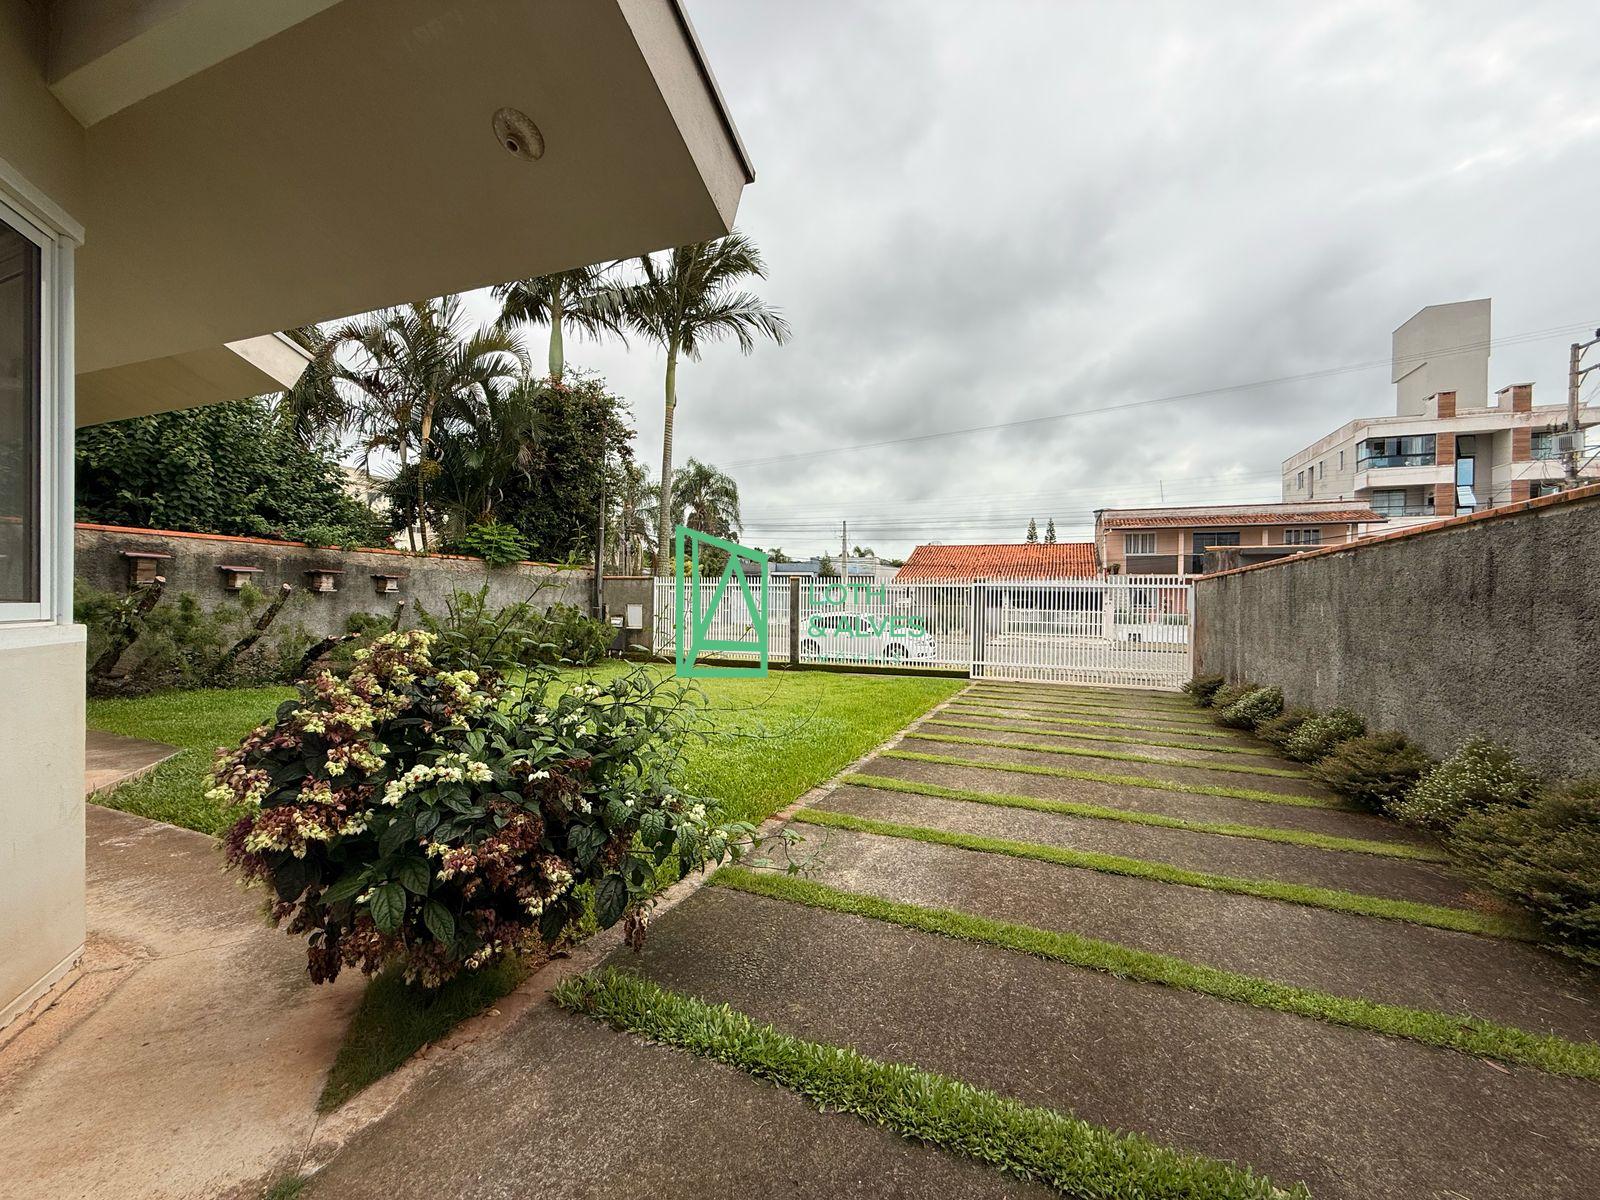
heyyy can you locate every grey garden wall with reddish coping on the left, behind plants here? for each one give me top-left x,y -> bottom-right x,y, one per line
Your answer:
77,525 -> 651,642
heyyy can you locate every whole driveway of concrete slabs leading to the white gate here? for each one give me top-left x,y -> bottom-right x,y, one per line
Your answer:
302,683 -> 1600,1200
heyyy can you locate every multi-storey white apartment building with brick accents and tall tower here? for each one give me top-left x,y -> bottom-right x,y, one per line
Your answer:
1283,299 -> 1600,526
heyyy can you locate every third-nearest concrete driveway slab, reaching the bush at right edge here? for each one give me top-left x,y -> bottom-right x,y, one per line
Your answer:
784,827 -> 1600,1040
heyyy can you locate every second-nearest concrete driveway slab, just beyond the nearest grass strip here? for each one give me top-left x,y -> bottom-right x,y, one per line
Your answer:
616,888 -> 1600,1200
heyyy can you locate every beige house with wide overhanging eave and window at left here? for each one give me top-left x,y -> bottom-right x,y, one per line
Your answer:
0,0 -> 752,1026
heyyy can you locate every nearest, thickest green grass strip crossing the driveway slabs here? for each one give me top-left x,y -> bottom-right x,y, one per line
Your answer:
554,970 -> 1309,1200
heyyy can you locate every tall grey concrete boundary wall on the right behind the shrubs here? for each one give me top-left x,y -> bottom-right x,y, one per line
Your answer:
1195,486 -> 1600,776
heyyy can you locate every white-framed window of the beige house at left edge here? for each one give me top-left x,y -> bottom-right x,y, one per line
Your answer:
0,203 -> 51,621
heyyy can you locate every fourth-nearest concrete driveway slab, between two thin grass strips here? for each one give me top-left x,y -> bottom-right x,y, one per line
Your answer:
816,786 -> 1477,907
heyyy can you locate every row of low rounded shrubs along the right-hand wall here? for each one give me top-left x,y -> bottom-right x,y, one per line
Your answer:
1186,675 -> 1600,965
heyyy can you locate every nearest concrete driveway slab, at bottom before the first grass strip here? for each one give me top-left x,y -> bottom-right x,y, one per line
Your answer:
307,998 -> 1046,1200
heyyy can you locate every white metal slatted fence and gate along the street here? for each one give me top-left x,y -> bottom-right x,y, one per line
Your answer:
653,574 -> 1192,688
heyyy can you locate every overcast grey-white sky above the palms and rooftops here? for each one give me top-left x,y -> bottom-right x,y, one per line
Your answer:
467,0 -> 1600,557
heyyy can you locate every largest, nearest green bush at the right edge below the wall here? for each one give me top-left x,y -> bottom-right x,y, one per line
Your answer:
1450,779 -> 1600,966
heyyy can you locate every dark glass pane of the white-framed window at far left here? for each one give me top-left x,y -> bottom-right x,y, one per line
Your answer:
0,219 -> 42,603
